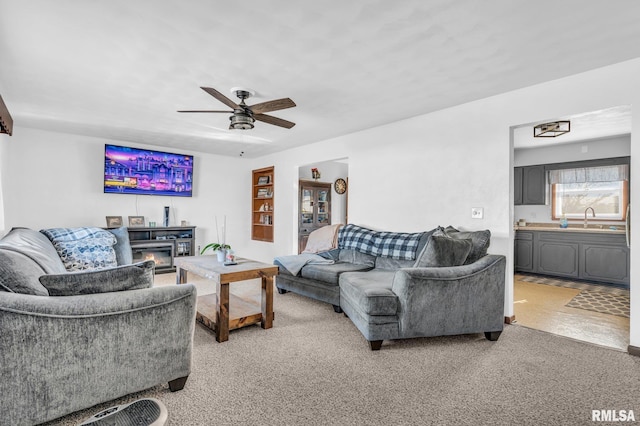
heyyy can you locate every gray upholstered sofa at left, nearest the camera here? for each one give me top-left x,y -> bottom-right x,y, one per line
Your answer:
0,228 -> 196,425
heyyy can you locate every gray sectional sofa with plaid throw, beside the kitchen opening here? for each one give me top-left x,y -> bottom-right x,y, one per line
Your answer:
274,225 -> 506,350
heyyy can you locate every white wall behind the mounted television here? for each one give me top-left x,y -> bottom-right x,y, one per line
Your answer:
0,128 -> 251,256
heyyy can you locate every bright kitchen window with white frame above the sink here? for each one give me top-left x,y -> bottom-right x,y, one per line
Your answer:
549,164 -> 629,221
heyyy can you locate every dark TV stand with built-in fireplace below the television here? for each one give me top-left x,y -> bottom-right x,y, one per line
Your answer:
127,226 -> 196,273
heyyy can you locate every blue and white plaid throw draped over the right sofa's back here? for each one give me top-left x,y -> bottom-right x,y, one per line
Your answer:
338,225 -> 424,260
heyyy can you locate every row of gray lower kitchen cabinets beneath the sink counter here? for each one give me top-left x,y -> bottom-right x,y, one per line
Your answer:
514,230 -> 630,287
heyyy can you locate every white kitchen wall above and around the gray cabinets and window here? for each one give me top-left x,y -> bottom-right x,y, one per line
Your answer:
513,135 -> 631,225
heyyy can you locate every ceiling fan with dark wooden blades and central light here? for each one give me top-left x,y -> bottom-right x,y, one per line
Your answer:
178,87 -> 296,130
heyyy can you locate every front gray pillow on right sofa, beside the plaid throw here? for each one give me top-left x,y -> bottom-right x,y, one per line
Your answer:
413,235 -> 472,268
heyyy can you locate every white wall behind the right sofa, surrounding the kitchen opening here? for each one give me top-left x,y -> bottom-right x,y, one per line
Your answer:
247,56 -> 640,346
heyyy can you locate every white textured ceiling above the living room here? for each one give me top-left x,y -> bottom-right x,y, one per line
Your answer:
0,0 -> 640,157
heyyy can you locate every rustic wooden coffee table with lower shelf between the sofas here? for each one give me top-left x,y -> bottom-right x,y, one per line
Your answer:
174,256 -> 278,342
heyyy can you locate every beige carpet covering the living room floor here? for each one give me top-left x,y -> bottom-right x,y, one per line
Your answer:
41,278 -> 640,426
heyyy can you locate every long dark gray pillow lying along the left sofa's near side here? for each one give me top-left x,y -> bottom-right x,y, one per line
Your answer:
40,260 -> 155,296
